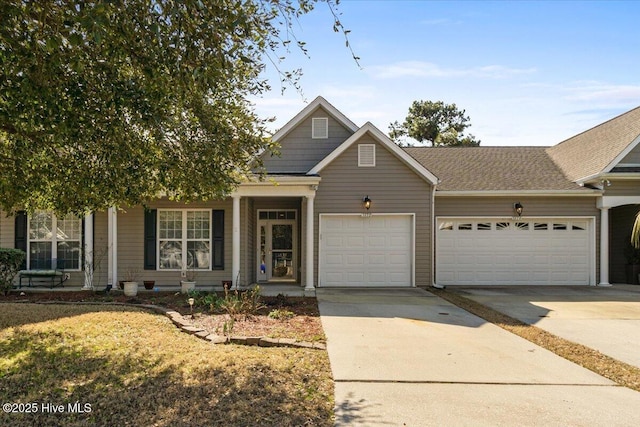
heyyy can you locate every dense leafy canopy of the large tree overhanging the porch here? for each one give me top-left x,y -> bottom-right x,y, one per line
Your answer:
0,0 -> 350,213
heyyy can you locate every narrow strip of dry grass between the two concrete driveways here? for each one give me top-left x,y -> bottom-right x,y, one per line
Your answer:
430,289 -> 640,391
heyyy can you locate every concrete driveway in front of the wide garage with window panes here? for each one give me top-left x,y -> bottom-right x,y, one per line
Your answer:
449,285 -> 640,368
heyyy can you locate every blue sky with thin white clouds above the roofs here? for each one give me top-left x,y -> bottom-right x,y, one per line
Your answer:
253,0 -> 640,146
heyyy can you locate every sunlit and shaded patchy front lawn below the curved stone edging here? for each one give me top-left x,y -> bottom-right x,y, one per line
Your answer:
0,303 -> 333,426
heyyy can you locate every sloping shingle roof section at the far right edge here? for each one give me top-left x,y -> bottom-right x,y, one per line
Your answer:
547,107 -> 640,182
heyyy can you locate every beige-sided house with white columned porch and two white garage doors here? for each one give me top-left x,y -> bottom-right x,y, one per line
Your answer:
0,97 -> 640,290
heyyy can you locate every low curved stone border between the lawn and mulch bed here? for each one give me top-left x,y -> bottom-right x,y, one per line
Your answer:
2,300 -> 327,350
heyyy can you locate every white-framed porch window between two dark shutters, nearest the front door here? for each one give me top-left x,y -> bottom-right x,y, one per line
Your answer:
158,210 -> 211,270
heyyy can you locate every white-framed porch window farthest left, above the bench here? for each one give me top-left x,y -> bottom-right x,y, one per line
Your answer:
28,211 -> 82,270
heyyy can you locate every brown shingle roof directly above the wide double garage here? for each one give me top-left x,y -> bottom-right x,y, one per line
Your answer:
404,147 -> 586,192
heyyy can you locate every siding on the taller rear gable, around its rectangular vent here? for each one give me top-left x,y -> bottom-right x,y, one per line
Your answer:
262,107 -> 352,173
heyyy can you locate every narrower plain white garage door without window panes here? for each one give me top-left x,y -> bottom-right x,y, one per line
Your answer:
318,214 -> 414,287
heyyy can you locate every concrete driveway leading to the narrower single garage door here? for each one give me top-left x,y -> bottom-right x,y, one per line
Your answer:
317,289 -> 640,426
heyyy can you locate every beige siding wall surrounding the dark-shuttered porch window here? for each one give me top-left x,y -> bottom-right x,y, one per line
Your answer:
117,199 -> 232,289
